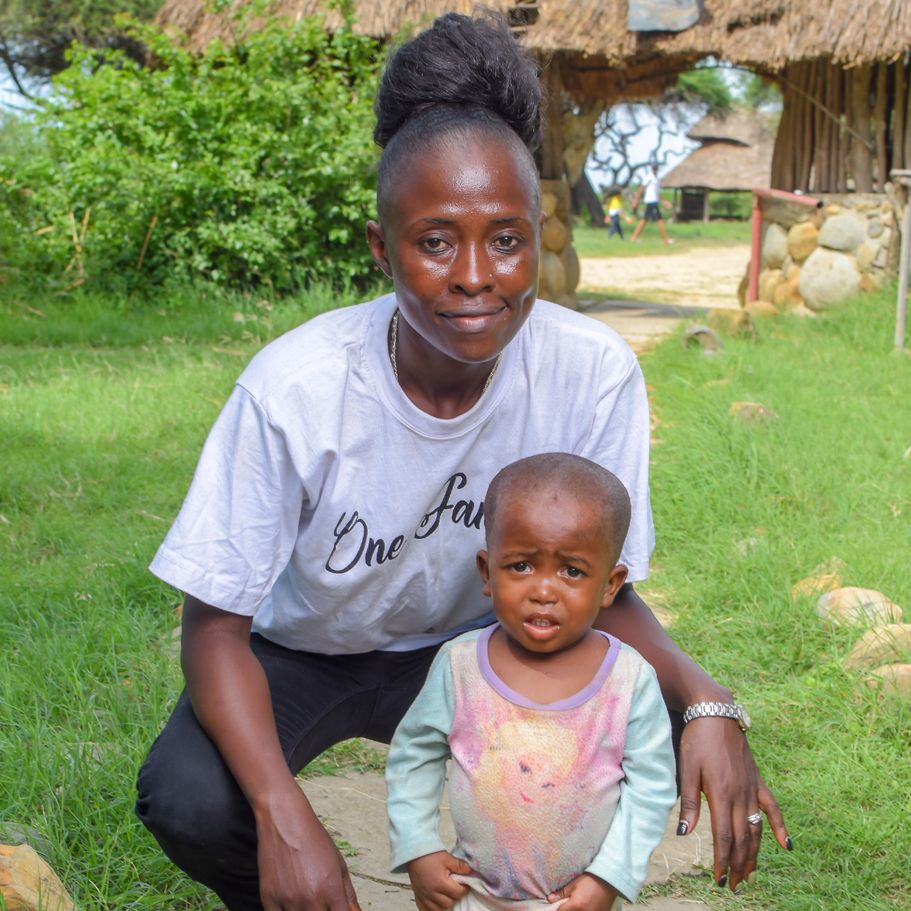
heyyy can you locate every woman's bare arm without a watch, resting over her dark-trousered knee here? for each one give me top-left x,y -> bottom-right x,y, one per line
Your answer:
181,595 -> 359,911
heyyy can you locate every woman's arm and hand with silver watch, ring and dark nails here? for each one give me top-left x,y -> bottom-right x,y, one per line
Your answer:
595,584 -> 791,889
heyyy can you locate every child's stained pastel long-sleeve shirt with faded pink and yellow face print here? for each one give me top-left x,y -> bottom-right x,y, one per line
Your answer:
386,627 -> 676,901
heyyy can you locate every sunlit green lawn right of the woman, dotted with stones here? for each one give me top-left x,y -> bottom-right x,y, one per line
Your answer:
644,290 -> 911,911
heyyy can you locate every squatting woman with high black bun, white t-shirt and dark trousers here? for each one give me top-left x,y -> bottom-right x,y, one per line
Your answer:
137,15 -> 787,911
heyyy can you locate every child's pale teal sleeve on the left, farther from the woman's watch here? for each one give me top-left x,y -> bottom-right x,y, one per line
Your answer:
386,646 -> 455,873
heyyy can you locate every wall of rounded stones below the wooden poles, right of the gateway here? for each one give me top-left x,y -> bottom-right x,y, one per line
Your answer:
752,193 -> 899,312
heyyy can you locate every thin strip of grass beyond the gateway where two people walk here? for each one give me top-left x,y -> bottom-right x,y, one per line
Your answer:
573,221 -> 750,257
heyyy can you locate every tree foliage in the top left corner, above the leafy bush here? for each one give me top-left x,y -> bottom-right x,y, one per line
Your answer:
0,0 -> 162,97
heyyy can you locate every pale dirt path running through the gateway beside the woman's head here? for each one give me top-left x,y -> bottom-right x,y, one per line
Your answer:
577,244 -> 750,354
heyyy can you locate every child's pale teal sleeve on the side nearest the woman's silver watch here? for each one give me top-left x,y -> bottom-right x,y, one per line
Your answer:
586,661 -> 677,902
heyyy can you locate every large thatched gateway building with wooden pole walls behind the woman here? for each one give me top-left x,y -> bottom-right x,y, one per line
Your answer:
158,0 -> 911,303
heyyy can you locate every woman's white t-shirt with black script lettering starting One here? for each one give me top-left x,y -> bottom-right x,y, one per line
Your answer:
151,294 -> 654,654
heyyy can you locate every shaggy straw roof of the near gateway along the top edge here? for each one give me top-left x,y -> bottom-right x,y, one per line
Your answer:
158,0 -> 911,76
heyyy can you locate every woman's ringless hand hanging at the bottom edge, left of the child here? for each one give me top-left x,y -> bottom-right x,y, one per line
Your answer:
256,785 -> 360,911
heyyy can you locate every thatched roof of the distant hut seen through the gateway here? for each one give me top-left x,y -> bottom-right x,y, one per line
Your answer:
661,111 -> 775,190
